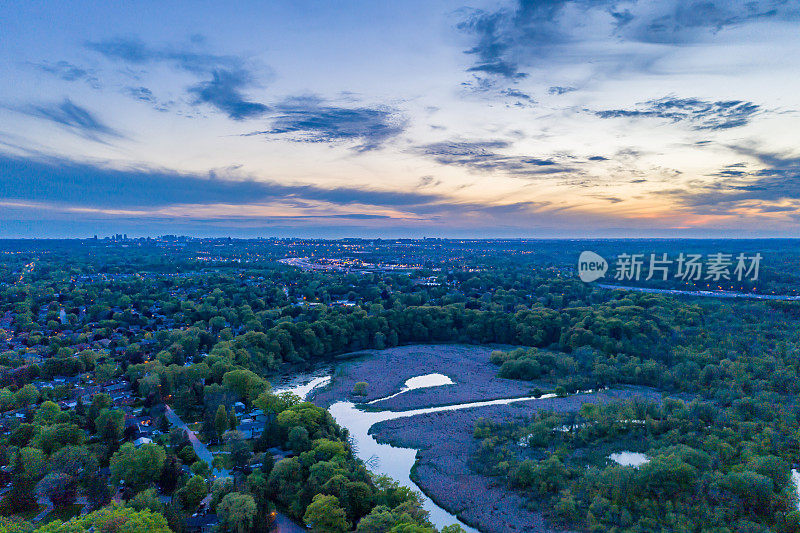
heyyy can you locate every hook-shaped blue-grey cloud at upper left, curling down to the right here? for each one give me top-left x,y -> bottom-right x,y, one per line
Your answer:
86,38 -> 268,120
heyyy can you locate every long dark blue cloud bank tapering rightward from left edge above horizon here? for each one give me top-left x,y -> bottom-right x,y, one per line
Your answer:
0,153 -> 443,209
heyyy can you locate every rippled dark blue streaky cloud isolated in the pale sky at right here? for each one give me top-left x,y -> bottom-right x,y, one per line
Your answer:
595,97 -> 761,130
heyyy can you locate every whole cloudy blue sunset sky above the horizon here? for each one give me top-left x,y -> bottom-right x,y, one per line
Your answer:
0,0 -> 800,238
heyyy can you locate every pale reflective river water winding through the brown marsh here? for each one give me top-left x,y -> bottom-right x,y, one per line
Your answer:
274,372 -> 568,533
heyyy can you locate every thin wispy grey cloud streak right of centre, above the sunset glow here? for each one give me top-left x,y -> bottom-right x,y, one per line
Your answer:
415,141 -> 575,178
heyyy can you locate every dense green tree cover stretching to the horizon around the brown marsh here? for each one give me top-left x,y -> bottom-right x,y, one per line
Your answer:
0,241 -> 800,533
